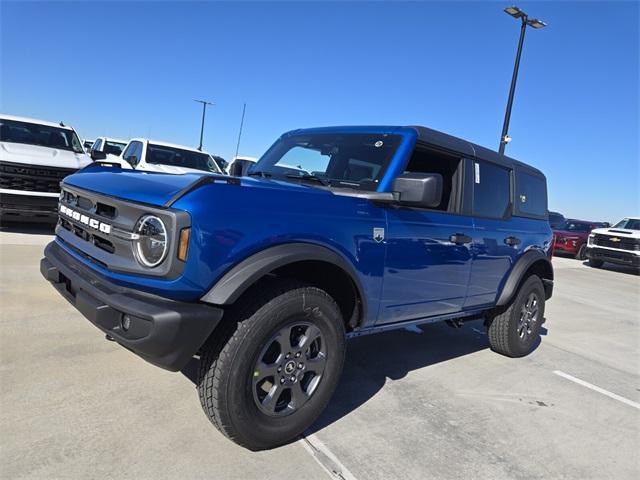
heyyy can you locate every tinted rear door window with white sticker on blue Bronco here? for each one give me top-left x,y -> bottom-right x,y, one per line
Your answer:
473,162 -> 511,218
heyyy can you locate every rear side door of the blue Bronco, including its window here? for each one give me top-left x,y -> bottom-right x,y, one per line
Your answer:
464,159 -> 525,307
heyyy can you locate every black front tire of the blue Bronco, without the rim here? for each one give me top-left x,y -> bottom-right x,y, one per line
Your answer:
198,280 -> 346,451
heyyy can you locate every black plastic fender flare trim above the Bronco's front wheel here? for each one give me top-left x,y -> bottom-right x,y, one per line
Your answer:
200,243 -> 367,318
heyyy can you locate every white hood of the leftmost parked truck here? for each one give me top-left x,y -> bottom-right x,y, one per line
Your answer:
0,142 -> 91,168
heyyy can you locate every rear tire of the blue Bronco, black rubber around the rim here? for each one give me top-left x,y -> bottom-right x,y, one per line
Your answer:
487,275 -> 545,358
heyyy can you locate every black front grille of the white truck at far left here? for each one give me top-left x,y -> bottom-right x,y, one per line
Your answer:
0,162 -> 76,193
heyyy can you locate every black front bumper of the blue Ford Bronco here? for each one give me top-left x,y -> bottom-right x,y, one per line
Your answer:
40,242 -> 223,371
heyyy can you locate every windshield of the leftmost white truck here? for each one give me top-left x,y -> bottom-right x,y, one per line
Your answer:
0,119 -> 84,153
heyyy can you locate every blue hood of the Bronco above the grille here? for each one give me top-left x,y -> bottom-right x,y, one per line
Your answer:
63,165 -> 330,206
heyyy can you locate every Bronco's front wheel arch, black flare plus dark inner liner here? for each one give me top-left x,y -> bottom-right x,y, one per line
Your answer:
200,243 -> 367,328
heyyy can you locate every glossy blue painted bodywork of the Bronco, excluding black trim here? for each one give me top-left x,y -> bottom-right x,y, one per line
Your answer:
59,127 -> 551,328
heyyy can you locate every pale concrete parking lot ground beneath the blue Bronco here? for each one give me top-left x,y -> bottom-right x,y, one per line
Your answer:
0,228 -> 640,479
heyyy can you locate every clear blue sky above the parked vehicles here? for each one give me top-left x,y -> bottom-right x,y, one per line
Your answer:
0,0 -> 640,221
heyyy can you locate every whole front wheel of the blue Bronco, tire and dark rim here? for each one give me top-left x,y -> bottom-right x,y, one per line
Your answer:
198,281 -> 345,450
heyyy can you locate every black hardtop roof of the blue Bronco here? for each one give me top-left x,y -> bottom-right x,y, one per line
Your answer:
407,125 -> 544,177
